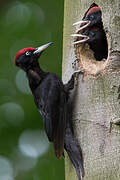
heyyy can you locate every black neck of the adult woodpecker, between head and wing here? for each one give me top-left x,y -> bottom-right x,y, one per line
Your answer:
26,62 -> 47,92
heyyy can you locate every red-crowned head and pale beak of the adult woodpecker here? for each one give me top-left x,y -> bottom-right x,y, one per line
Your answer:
15,42 -> 52,71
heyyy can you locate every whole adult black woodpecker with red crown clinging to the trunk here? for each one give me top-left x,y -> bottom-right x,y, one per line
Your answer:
15,43 -> 84,180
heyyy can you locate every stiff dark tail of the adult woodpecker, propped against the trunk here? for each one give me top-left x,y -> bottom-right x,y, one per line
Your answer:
64,126 -> 84,180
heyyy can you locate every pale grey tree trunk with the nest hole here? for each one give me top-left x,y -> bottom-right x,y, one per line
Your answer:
62,0 -> 120,180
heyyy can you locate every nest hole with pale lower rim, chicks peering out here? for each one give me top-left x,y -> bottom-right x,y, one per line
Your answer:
74,4 -> 109,76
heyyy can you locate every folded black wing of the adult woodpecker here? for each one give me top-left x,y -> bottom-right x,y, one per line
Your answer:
38,75 -> 66,157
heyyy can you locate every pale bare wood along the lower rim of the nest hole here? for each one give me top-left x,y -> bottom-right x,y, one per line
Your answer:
74,44 -> 109,76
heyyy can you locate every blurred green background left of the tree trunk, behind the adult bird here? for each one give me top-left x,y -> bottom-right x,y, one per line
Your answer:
0,0 -> 64,180
